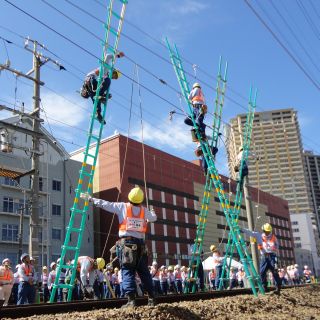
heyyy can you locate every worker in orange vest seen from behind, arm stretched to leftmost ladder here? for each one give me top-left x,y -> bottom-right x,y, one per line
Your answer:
80,187 -> 157,307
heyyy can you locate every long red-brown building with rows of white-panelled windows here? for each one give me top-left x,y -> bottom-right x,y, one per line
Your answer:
83,135 -> 293,265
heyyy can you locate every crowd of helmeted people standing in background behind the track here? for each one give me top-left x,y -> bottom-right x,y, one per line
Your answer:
0,254 -> 313,305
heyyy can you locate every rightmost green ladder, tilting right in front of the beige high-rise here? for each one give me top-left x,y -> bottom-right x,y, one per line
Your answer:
218,88 -> 257,290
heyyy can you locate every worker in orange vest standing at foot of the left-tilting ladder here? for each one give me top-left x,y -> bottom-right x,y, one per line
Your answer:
241,223 -> 281,294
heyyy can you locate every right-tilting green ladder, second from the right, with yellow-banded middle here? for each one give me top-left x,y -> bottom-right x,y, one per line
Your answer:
184,57 -> 228,293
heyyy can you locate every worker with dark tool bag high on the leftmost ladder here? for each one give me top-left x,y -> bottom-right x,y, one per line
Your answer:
80,52 -> 124,124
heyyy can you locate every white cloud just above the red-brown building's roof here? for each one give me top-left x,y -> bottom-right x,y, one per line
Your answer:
131,118 -> 195,151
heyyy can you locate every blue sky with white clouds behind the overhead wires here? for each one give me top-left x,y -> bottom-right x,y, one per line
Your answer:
0,0 -> 320,173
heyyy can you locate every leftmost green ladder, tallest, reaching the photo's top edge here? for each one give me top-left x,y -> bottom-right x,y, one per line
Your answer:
50,0 -> 128,302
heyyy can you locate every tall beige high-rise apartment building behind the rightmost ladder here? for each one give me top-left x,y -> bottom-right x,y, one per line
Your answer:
227,109 -> 313,213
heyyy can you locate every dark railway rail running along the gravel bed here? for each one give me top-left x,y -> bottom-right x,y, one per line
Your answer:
0,285 -> 312,319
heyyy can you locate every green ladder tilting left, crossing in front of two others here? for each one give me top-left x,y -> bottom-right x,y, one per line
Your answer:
166,39 -> 264,296
